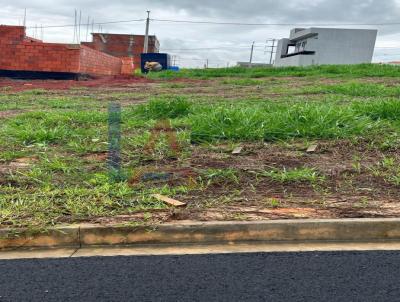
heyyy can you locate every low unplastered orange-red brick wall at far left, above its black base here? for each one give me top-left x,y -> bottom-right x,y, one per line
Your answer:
0,25 -> 133,75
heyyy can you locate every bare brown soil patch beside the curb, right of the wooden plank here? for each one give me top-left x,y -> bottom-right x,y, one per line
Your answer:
121,141 -> 400,221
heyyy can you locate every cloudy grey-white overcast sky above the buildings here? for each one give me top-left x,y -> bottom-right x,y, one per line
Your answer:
0,0 -> 400,67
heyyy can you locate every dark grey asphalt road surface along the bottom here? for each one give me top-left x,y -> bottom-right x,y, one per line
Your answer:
0,252 -> 400,302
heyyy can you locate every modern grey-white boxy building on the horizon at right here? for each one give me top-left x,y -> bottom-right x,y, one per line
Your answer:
274,27 -> 378,66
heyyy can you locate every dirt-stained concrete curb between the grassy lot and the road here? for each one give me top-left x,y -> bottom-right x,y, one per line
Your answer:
0,218 -> 400,249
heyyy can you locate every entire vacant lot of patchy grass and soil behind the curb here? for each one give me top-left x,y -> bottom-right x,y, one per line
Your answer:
0,65 -> 400,229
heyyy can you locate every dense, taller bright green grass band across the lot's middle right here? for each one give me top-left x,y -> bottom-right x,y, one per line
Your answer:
125,96 -> 400,143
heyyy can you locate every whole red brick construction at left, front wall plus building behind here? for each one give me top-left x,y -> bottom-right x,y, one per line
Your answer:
0,25 -> 159,79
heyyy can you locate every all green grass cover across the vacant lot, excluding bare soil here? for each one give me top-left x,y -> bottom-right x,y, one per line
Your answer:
0,65 -> 400,228
